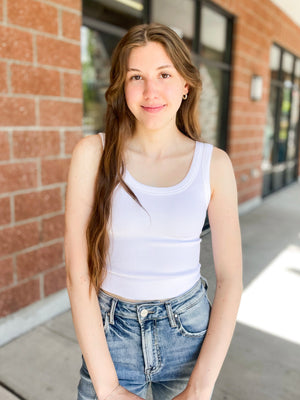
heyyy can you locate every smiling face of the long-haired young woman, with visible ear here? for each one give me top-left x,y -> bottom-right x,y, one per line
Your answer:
125,42 -> 188,134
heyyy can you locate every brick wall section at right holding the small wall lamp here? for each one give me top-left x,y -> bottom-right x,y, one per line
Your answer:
214,0 -> 300,203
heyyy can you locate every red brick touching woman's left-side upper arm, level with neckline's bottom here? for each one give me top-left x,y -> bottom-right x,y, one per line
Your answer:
15,189 -> 62,221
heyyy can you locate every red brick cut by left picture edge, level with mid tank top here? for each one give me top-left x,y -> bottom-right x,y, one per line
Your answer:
0,222 -> 39,256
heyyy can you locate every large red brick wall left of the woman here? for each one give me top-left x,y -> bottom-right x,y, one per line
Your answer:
0,0 -> 82,317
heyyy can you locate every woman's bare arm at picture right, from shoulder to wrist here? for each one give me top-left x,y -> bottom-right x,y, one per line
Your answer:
176,147 -> 243,400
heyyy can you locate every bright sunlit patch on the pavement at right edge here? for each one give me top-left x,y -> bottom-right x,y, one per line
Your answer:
237,242 -> 300,344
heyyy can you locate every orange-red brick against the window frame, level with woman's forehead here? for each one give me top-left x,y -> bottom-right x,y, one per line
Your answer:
36,36 -> 81,70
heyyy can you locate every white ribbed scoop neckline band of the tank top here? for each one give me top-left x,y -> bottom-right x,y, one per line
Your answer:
125,140 -> 200,194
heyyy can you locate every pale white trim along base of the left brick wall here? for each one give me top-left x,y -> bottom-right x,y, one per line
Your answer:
0,289 -> 70,346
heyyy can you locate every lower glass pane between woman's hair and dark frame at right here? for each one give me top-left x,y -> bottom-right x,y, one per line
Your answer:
199,64 -> 222,146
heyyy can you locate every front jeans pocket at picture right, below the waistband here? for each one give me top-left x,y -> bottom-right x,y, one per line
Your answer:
174,295 -> 211,337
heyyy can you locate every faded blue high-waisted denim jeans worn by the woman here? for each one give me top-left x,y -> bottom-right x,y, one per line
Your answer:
77,280 -> 211,400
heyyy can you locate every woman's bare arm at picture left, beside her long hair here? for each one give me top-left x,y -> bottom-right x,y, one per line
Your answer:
65,135 -> 119,400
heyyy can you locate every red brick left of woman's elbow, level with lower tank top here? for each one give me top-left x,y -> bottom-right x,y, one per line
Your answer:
17,243 -> 63,280
